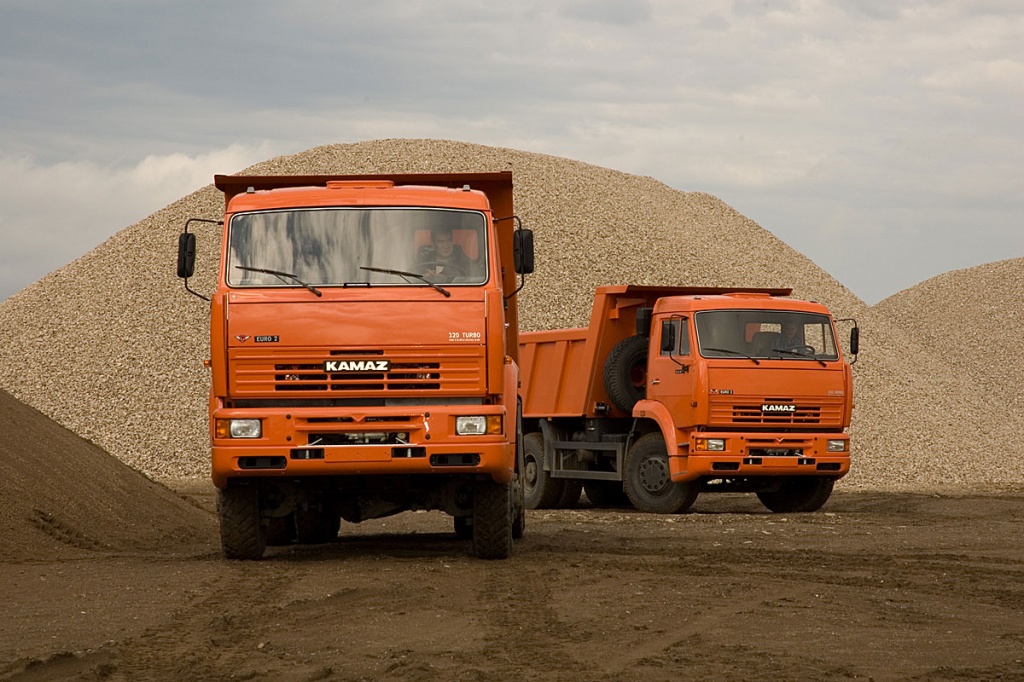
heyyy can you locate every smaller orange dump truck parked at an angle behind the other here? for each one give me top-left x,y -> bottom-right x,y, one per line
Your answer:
519,286 -> 859,513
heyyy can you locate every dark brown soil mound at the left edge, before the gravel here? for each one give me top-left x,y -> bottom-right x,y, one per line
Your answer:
0,391 -> 217,561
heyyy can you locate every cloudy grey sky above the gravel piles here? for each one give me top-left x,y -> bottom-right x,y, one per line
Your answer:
0,0 -> 1024,304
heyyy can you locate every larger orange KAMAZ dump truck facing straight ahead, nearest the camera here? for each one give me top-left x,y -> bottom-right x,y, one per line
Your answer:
178,172 -> 532,559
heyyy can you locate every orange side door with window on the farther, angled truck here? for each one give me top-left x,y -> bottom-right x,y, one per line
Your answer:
646,314 -> 693,426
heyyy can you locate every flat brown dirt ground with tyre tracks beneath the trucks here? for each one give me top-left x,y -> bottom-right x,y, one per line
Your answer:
0,481 -> 1024,682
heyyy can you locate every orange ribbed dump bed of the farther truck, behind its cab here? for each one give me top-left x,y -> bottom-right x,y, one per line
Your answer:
519,285 -> 790,418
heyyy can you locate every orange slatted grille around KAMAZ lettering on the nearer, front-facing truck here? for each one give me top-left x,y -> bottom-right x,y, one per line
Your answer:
230,346 -> 485,397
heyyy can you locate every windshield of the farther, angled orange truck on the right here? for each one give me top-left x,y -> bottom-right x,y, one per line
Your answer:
694,310 -> 839,360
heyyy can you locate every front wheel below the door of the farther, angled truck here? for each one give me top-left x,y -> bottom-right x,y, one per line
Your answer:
623,432 -> 700,514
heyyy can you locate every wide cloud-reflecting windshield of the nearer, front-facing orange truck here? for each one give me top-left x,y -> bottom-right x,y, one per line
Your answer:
226,208 -> 487,287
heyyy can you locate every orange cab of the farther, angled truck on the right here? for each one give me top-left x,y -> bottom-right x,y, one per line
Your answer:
633,293 -> 852,493
